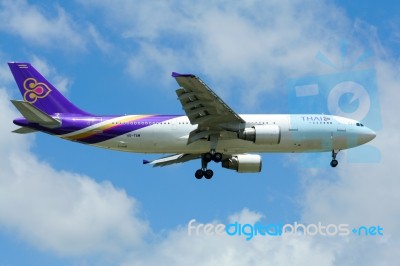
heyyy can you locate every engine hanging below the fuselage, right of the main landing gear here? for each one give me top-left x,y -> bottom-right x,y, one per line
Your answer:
222,154 -> 262,173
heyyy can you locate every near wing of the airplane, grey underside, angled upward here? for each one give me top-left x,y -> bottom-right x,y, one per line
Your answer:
172,72 -> 245,131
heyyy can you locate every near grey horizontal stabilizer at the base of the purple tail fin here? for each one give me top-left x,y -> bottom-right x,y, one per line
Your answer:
11,100 -> 61,128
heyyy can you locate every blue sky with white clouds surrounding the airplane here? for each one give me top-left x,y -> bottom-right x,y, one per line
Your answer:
0,0 -> 400,265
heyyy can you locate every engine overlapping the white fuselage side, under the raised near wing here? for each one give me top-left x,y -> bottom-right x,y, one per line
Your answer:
238,125 -> 281,144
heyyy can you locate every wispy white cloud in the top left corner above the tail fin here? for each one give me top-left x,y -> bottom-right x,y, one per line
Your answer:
0,0 -> 112,53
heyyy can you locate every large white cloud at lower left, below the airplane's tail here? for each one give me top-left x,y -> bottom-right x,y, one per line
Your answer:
0,89 -> 148,256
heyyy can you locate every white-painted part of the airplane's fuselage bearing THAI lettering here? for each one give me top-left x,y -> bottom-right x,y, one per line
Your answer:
92,114 -> 375,154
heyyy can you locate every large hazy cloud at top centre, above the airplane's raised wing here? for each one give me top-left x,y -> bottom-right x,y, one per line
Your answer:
76,1 -> 348,108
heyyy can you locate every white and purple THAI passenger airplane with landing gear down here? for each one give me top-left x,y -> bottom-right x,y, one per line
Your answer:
8,62 -> 376,179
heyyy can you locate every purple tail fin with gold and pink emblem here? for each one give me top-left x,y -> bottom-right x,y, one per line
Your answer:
8,63 -> 88,115
